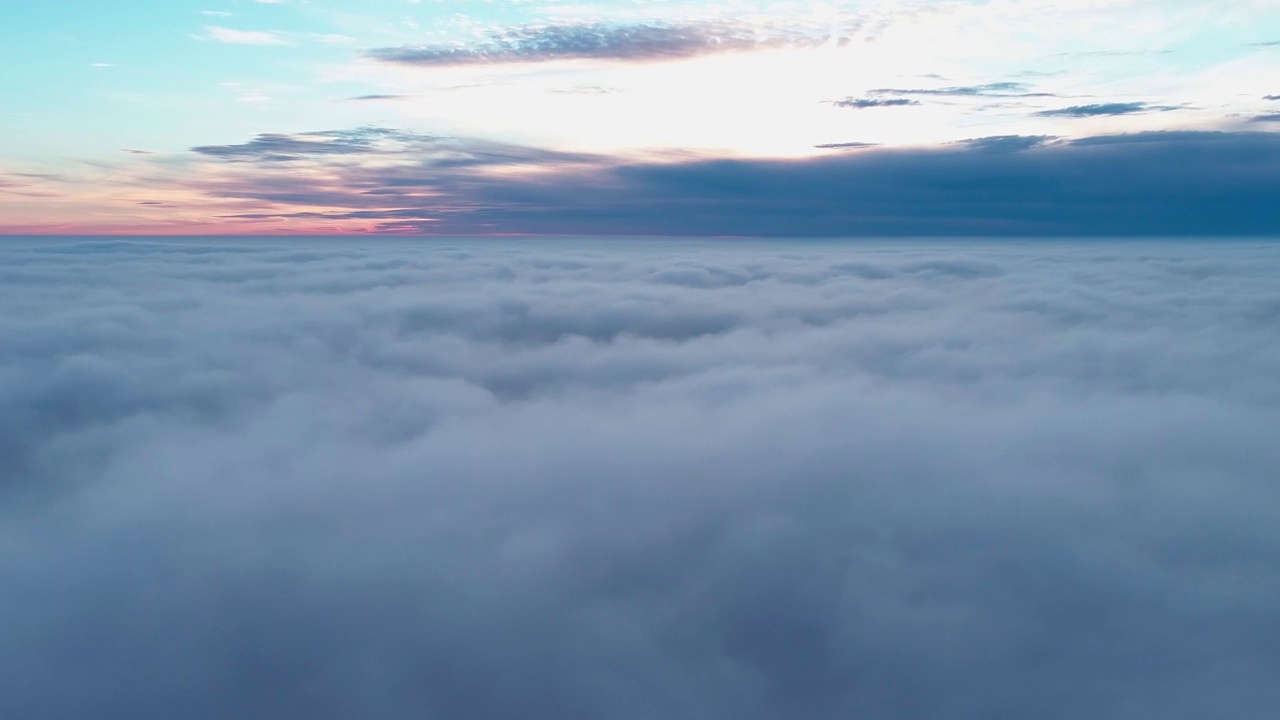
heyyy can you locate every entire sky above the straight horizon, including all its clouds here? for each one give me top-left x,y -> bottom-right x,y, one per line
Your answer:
0,0 -> 1280,236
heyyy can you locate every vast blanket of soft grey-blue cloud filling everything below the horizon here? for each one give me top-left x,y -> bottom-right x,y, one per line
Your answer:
0,238 -> 1280,720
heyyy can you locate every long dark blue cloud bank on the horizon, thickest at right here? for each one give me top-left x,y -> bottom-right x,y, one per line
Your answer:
197,126 -> 1280,237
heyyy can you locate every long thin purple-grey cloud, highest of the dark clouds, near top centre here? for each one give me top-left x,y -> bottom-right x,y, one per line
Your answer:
366,23 -> 827,67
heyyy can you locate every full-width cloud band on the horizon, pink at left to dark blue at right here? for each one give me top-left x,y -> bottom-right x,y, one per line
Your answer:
8,120 -> 1280,236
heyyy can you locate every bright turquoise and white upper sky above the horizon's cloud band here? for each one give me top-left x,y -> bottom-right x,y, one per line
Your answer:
0,0 -> 1280,229
